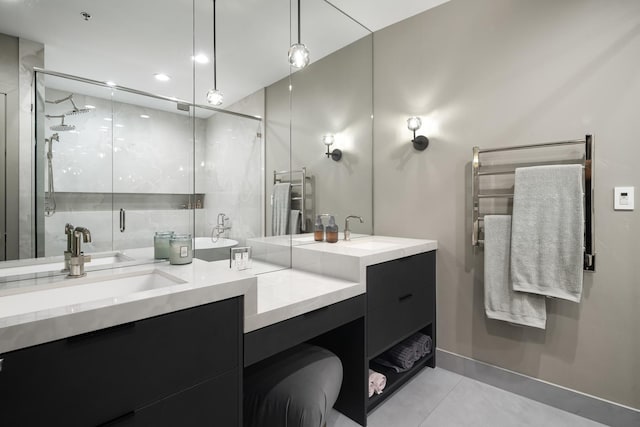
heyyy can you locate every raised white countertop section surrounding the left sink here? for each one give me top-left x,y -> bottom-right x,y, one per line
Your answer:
0,259 -> 257,354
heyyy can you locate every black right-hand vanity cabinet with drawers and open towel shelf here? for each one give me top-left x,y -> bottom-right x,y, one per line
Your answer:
367,251 -> 436,410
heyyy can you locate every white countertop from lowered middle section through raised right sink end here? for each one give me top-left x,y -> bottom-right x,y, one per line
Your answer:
244,235 -> 438,332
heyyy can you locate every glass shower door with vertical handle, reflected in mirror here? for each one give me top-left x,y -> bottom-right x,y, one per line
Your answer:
111,90 -> 197,260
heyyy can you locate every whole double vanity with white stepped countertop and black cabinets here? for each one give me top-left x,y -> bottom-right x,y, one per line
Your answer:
0,235 -> 437,426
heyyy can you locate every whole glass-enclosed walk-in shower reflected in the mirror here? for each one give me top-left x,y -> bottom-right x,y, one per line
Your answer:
34,70 -> 264,260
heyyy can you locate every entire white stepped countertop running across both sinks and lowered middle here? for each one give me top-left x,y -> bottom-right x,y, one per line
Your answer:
0,235 -> 437,354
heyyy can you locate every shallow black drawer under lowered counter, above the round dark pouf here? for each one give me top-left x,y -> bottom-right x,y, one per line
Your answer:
244,295 -> 365,366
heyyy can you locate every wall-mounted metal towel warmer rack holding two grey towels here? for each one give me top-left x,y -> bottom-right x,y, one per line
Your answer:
471,135 -> 596,271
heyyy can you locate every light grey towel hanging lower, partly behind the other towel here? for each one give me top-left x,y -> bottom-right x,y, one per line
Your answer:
484,215 -> 547,329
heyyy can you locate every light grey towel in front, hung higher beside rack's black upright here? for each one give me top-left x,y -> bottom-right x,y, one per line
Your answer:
511,165 -> 584,302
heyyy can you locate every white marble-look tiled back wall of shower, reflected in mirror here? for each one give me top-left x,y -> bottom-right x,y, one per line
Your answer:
45,88 -> 207,256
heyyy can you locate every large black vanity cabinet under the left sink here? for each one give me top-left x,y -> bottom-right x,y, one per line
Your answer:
0,297 -> 243,426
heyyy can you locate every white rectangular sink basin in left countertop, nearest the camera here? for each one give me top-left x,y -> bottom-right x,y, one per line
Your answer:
0,270 -> 186,317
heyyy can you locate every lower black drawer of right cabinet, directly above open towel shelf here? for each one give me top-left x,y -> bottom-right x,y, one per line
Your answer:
367,293 -> 435,357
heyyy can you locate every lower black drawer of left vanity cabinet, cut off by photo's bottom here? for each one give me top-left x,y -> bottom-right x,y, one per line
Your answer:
104,370 -> 242,427
